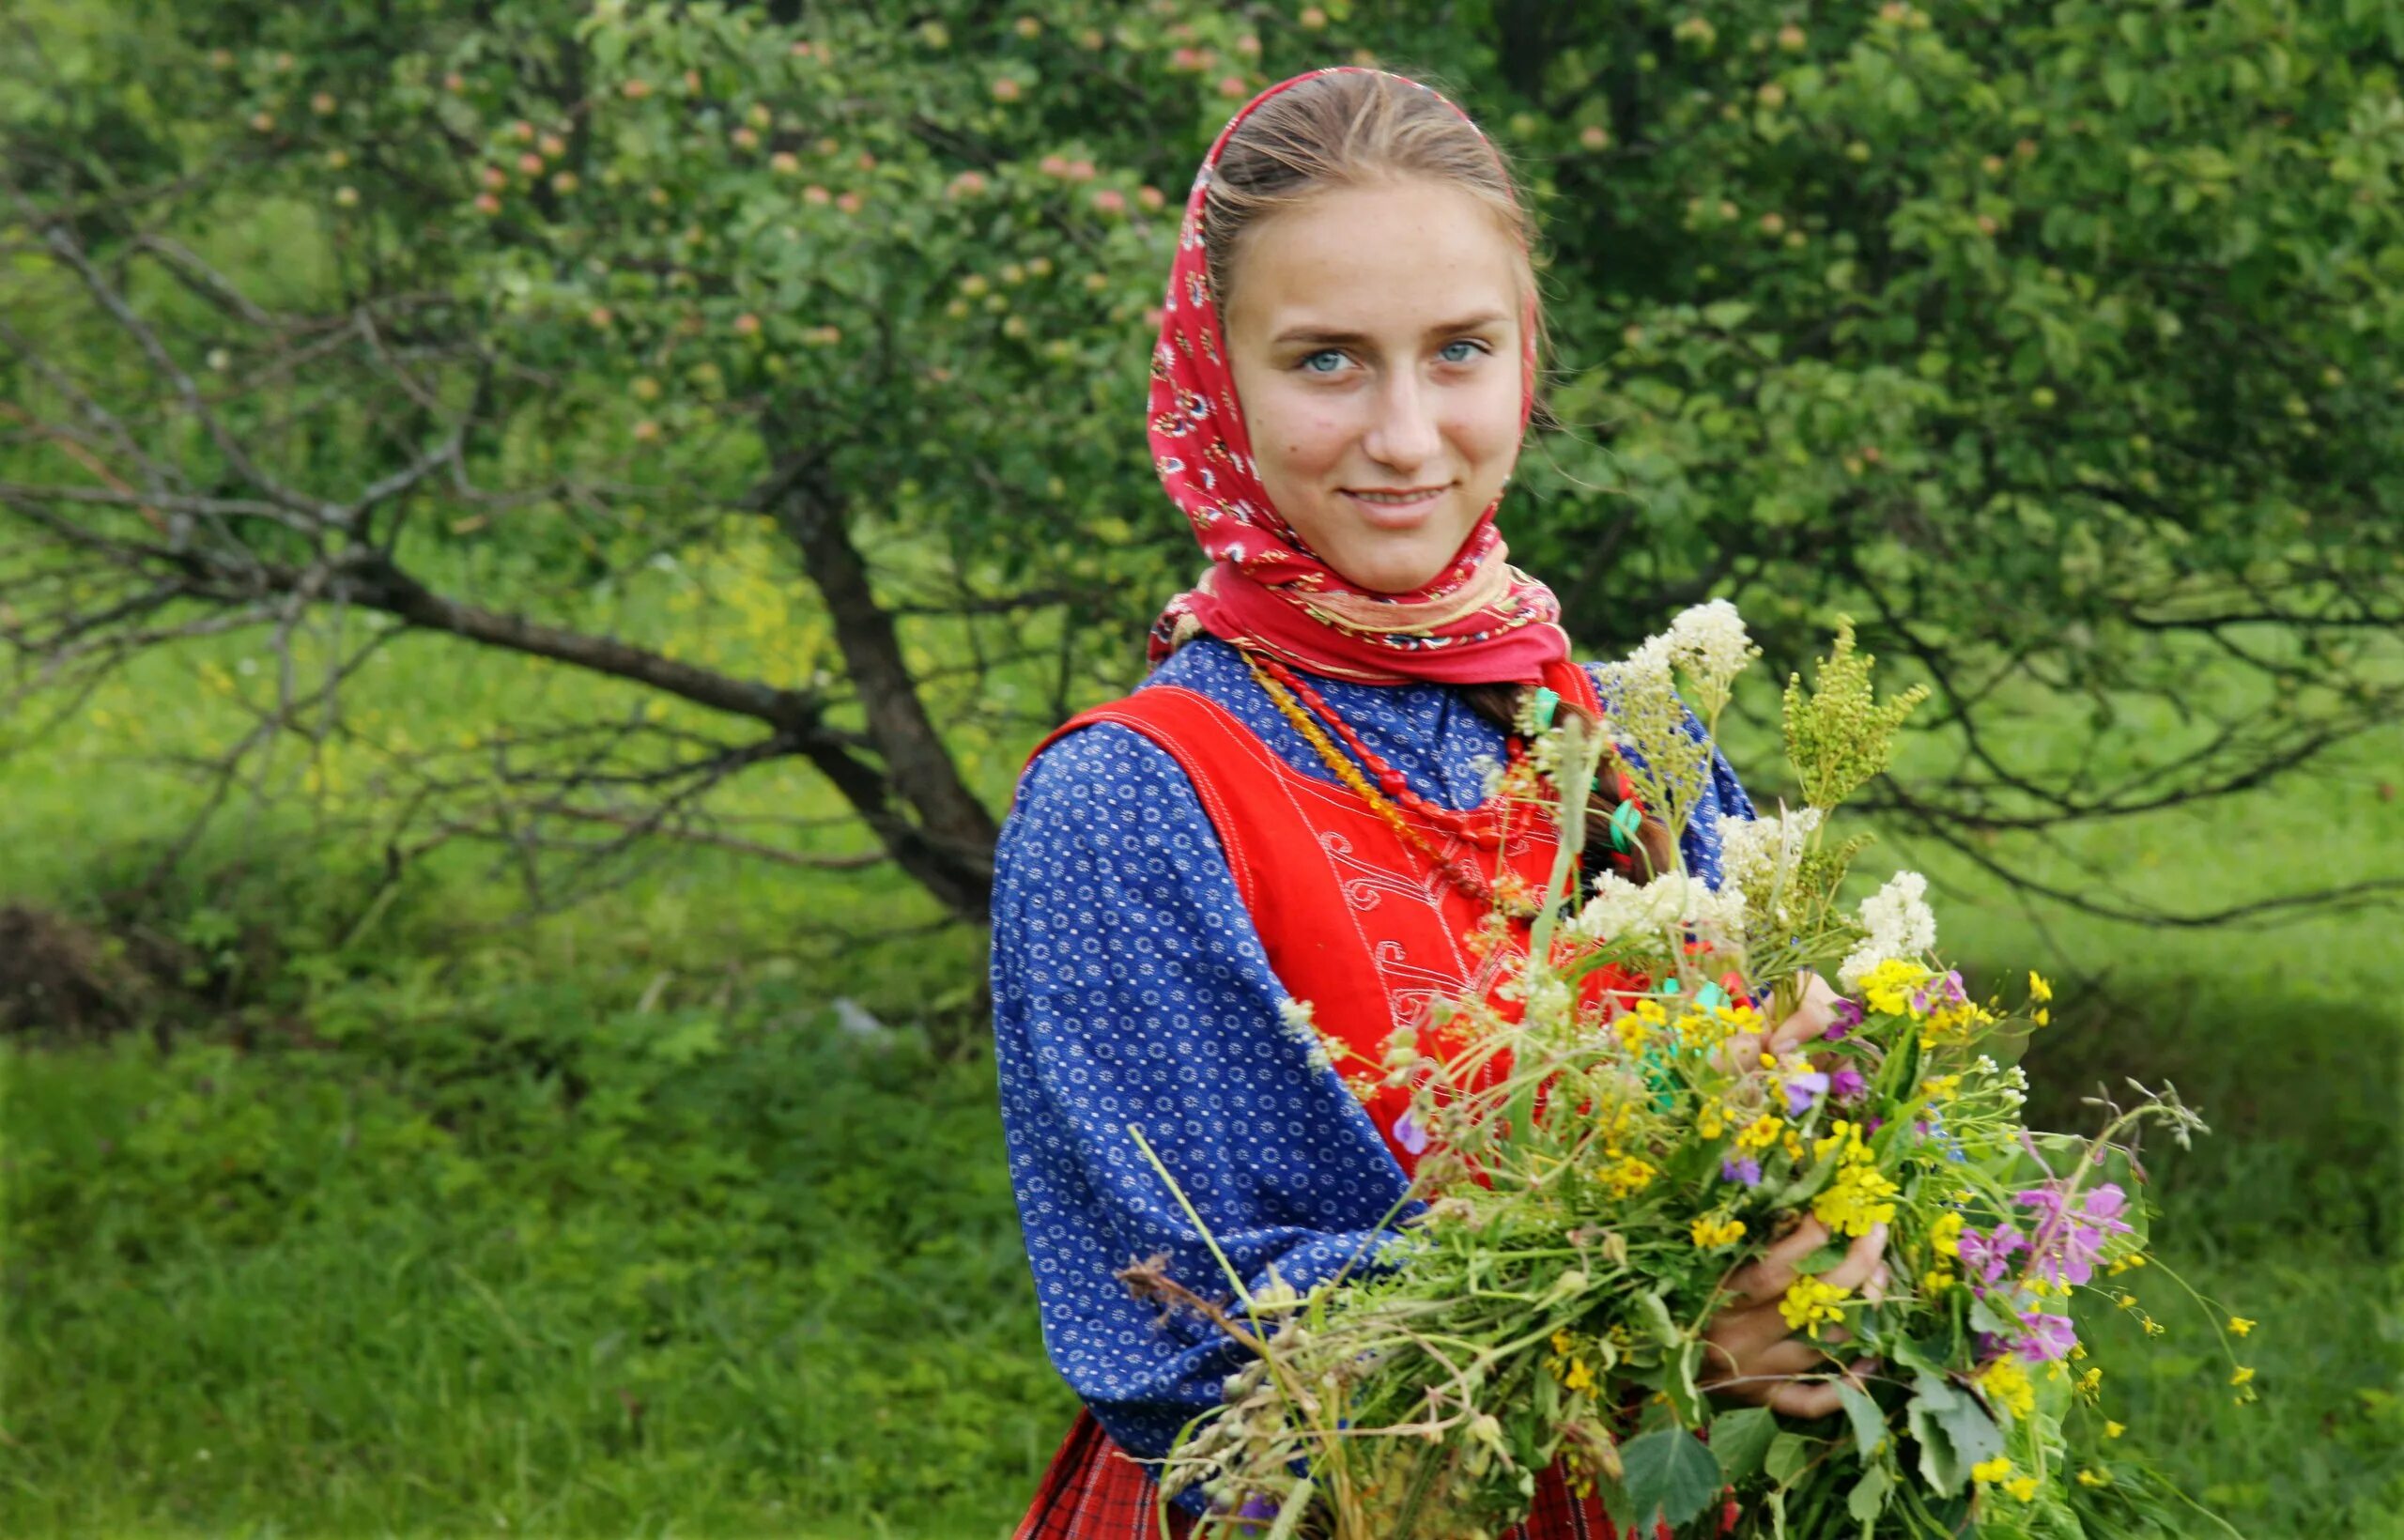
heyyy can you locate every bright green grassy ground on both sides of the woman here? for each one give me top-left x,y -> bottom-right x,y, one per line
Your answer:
0,620 -> 2404,1540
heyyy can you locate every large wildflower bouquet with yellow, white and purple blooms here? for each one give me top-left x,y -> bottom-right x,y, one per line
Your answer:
1125,603 -> 2253,1540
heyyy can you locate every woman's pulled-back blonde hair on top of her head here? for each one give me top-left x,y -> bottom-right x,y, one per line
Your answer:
1202,69 -> 1544,379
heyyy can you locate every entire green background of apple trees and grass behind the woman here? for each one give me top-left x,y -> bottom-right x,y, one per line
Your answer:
0,0 -> 2404,1540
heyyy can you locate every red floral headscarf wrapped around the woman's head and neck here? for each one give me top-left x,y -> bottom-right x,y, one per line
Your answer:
1149,65 -> 1570,685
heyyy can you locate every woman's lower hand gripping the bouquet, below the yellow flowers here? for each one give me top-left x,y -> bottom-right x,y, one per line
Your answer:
1702,1218 -> 1888,1418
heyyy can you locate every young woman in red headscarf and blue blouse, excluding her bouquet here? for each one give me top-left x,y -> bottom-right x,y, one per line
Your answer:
993,69 -> 1882,1540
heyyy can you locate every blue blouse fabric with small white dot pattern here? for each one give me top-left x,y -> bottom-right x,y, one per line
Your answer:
993,639 -> 1752,1511
